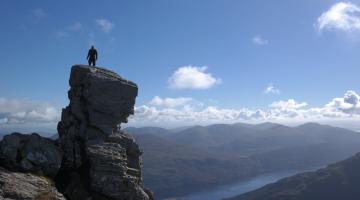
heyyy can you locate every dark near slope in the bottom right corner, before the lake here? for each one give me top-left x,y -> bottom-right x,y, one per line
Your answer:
228,154 -> 360,200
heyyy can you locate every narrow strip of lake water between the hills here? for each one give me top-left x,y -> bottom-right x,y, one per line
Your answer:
170,167 -> 320,200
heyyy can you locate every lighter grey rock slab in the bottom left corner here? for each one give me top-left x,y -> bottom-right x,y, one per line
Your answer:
0,167 -> 65,200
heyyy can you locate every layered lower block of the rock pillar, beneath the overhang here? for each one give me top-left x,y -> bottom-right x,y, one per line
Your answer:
87,133 -> 149,200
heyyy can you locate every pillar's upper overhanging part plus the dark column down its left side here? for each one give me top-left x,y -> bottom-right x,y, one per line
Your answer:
58,65 -> 138,168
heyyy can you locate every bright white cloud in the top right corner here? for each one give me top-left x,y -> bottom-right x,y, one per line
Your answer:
316,2 -> 360,31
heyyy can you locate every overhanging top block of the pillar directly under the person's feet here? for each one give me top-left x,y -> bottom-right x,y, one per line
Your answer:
69,65 -> 138,134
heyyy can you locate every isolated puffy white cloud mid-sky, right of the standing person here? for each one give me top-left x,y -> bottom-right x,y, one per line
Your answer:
168,66 -> 221,89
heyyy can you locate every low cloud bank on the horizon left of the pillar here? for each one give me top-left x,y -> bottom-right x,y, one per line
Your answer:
0,98 -> 60,125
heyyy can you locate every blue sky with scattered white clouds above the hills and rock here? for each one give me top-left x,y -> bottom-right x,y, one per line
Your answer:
0,0 -> 360,133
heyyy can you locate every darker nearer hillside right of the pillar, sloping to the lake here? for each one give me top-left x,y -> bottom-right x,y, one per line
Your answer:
135,134 -> 259,198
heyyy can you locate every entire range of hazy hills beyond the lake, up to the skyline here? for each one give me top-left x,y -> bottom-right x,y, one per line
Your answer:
125,123 -> 360,199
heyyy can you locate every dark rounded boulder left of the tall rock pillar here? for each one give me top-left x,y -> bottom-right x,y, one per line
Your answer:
0,133 -> 62,177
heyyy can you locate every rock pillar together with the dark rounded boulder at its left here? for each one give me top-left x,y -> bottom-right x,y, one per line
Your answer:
0,65 -> 153,200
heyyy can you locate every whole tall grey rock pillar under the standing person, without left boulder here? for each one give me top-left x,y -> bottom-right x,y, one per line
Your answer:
58,65 -> 152,200
